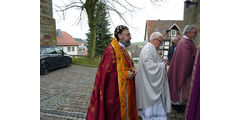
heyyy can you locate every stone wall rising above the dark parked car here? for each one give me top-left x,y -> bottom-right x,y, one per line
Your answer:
40,0 -> 56,46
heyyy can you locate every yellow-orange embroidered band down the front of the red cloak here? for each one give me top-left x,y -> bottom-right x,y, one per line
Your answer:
111,37 -> 128,120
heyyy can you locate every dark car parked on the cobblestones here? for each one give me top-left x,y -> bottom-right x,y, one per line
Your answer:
40,46 -> 72,75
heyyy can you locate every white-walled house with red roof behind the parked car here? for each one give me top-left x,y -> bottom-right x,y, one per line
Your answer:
57,29 -> 78,55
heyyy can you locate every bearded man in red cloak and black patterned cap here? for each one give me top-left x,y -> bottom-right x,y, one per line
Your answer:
87,25 -> 138,120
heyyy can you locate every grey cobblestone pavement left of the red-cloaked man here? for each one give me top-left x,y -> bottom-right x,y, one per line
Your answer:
40,65 -> 97,120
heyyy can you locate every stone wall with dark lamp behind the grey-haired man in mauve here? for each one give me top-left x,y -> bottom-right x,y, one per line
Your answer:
183,0 -> 200,45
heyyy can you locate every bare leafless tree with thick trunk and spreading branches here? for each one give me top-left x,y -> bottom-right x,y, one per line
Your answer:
56,0 -> 140,59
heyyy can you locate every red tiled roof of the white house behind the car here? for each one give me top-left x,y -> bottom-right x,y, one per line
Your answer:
57,31 -> 78,45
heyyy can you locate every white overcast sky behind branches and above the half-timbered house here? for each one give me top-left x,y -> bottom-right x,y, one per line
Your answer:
52,0 -> 184,42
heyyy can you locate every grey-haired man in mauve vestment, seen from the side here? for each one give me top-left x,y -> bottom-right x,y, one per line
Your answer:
167,25 -> 197,112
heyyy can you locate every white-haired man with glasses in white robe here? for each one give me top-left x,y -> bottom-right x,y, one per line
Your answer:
135,32 -> 171,120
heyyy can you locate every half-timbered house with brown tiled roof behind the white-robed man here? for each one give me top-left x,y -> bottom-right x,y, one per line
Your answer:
144,20 -> 183,60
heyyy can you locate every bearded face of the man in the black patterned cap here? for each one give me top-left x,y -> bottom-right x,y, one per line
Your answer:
119,29 -> 132,47
